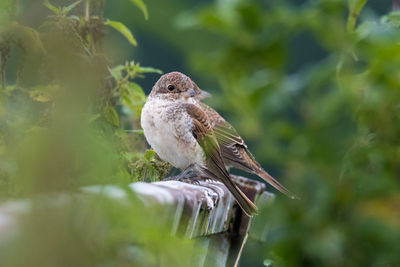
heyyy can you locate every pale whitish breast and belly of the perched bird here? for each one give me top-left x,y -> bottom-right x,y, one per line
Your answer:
141,99 -> 204,169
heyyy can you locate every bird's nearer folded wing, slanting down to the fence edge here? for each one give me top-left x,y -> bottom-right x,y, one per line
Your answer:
186,104 -> 257,216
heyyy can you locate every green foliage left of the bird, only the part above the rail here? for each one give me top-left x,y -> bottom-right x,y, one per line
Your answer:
0,1 -> 165,198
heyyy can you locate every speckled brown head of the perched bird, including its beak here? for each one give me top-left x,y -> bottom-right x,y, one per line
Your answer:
150,71 -> 211,101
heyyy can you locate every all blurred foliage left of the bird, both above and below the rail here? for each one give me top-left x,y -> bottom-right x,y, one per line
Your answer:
0,0 -> 195,266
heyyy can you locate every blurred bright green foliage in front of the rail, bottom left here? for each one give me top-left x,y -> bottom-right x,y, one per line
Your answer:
0,188 -> 202,267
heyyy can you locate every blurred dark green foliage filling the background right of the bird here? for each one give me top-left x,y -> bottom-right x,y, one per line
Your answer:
177,0 -> 400,266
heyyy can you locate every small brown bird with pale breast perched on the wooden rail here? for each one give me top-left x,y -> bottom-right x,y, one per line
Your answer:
141,72 -> 289,215
